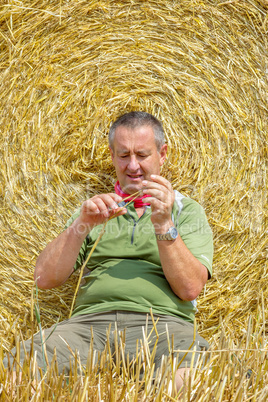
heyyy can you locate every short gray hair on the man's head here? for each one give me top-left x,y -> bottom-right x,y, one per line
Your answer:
109,112 -> 165,151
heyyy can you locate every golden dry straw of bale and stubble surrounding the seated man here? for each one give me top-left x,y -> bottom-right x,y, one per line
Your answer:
0,0 -> 268,401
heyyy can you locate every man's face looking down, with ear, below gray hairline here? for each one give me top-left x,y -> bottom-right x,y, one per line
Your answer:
110,126 -> 167,194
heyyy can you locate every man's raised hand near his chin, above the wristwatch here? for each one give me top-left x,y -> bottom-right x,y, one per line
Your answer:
142,175 -> 175,234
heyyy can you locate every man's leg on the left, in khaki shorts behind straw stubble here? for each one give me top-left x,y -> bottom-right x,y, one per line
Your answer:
3,313 -> 116,373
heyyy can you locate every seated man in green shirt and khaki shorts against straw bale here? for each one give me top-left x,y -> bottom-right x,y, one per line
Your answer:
4,112 -> 213,389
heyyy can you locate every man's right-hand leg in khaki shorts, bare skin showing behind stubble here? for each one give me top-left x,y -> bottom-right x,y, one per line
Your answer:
114,312 -> 209,391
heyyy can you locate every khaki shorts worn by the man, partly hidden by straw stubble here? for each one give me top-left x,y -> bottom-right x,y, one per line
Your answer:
3,311 -> 209,374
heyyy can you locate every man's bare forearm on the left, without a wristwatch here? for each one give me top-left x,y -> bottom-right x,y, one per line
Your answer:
34,217 -> 90,289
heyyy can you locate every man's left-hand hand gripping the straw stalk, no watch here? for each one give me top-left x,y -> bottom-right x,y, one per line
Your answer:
78,193 -> 127,230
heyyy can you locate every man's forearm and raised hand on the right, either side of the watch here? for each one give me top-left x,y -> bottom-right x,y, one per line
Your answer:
142,175 -> 208,301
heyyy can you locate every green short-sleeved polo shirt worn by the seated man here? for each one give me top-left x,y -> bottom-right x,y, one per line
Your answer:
66,191 -> 213,322
